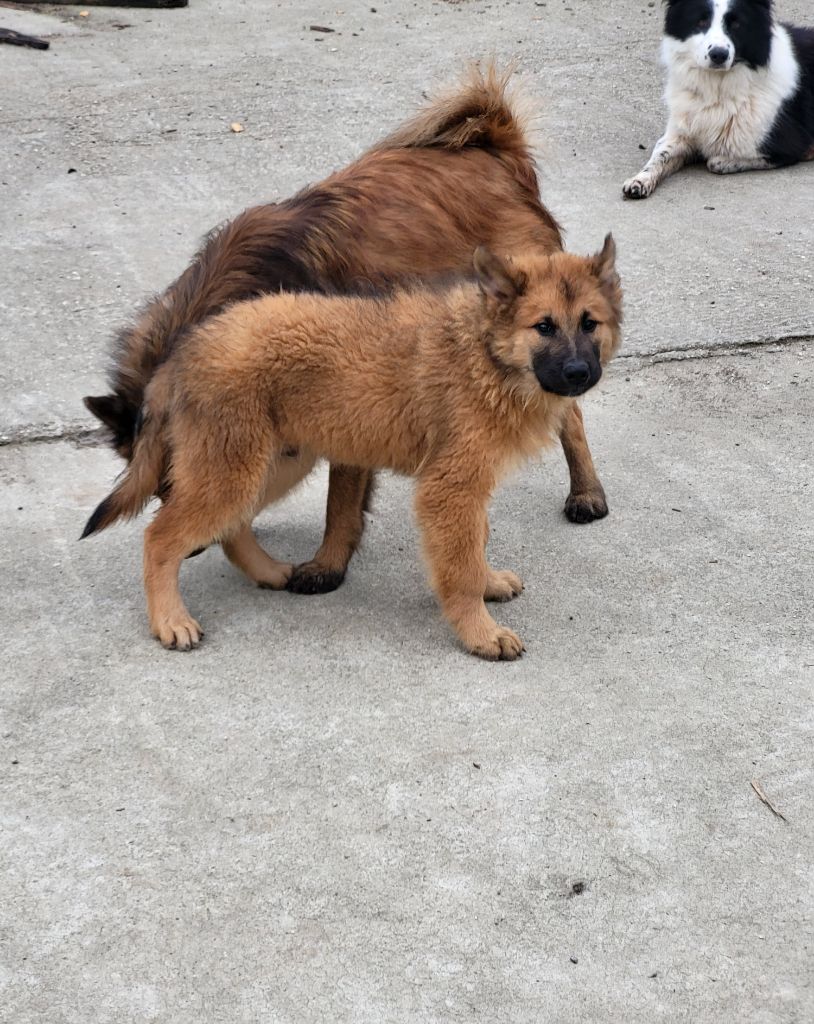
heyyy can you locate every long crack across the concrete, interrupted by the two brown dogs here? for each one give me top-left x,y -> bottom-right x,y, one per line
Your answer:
0,334 -> 814,449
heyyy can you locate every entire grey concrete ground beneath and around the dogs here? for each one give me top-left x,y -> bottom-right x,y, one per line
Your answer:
0,0 -> 814,1024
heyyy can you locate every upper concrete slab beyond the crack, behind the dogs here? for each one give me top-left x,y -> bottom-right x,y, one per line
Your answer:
0,0 -> 814,439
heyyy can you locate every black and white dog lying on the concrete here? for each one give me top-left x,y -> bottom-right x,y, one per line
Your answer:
623,0 -> 814,199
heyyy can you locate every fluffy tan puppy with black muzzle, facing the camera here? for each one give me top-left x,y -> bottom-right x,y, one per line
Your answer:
83,236 -> 622,660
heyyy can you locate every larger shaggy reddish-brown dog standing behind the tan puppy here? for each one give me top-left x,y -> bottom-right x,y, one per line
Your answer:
85,70 -> 607,594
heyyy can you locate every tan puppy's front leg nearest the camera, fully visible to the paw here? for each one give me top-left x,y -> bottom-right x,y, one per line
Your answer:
416,469 -> 524,662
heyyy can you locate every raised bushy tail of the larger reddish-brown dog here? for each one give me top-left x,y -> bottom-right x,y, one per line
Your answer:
374,63 -> 538,197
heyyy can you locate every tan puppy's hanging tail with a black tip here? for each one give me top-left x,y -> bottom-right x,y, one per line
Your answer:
80,385 -> 166,541
